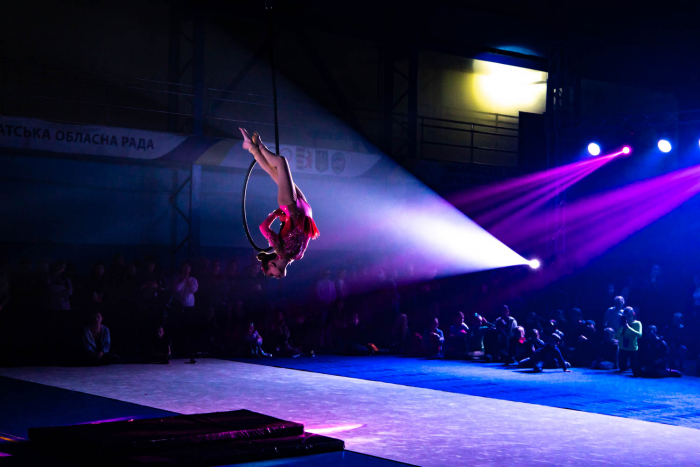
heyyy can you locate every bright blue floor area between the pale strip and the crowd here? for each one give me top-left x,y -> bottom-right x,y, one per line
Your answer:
238,355 -> 700,429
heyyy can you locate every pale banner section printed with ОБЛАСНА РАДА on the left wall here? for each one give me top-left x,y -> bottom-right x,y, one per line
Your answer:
0,116 -> 187,159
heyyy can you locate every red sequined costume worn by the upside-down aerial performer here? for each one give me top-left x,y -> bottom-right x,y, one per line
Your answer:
260,189 -> 319,260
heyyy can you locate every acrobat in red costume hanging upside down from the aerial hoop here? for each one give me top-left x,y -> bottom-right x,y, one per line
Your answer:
239,128 -> 319,279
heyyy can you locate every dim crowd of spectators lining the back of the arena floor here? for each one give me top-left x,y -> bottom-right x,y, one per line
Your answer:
0,254 -> 700,378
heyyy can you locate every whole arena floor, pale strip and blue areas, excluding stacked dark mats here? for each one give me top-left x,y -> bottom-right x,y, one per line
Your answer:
0,356 -> 700,466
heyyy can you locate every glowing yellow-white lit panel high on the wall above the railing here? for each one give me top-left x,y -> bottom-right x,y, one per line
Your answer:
466,60 -> 547,115
